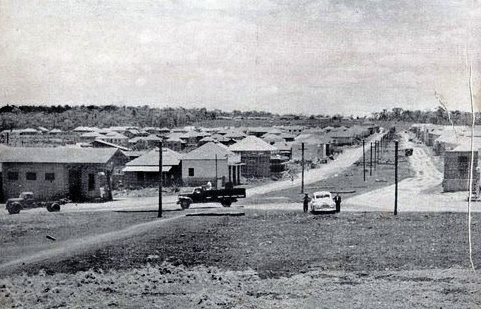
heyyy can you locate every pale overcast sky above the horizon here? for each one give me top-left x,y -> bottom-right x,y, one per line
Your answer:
0,0 -> 481,114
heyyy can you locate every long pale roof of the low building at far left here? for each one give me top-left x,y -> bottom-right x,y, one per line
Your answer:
0,147 -> 120,163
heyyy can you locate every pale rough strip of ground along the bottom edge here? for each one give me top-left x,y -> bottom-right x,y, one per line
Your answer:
0,264 -> 481,308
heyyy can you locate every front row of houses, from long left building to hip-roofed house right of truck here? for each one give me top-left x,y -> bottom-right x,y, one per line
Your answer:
0,136 -> 277,201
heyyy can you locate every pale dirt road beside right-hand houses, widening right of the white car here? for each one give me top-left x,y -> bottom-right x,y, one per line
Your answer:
344,135 -> 474,212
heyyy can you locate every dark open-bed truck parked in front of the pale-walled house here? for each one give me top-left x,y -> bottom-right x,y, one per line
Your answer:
177,186 -> 246,209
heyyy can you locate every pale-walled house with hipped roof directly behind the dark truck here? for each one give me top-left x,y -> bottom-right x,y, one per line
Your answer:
182,142 -> 242,187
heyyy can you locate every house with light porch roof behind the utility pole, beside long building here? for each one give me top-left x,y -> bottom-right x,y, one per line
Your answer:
122,148 -> 182,188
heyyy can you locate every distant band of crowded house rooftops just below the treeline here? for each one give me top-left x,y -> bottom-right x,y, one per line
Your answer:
0,123 -> 378,152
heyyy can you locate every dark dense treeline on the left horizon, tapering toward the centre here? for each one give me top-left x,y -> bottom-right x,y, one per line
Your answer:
0,105 -> 273,130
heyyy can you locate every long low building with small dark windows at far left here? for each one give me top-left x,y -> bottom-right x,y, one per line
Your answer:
0,147 -> 127,202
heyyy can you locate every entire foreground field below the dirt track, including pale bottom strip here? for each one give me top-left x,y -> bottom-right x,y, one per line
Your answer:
0,211 -> 481,308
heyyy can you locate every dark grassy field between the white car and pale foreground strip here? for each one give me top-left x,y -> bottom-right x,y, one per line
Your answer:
11,210 -> 481,277
